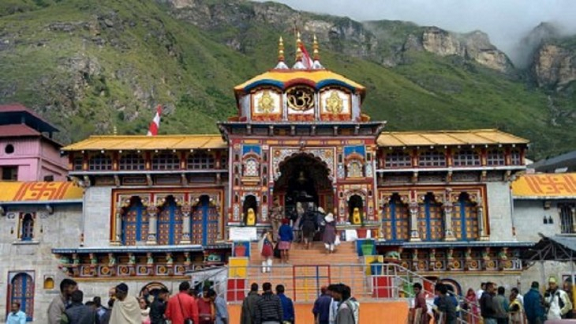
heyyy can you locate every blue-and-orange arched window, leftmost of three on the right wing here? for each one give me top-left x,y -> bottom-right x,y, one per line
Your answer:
382,194 -> 410,241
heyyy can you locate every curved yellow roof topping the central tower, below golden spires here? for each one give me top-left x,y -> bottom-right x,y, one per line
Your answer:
234,69 -> 366,95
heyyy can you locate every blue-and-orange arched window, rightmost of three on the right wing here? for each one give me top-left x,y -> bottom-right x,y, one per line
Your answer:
452,192 -> 478,241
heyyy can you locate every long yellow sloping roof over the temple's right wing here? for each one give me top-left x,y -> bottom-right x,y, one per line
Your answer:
377,129 -> 528,147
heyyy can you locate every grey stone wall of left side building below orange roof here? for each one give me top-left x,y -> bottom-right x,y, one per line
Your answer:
0,204 -> 82,323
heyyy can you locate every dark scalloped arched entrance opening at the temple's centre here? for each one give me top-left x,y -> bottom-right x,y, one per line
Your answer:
274,153 -> 334,219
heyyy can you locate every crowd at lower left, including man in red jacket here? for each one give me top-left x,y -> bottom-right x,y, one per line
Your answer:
39,279 -> 229,324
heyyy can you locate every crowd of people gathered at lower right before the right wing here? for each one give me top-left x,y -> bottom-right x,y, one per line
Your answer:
411,277 -> 575,324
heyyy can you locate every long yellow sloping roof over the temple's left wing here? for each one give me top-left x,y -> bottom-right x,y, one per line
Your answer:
62,135 -> 228,151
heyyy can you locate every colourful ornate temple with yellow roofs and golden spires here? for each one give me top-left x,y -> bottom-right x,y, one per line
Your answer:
0,36 -> 576,323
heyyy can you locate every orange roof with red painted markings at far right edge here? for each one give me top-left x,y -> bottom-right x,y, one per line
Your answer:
512,173 -> 576,199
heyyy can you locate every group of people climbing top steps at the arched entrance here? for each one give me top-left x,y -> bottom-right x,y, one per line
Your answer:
258,199 -> 340,273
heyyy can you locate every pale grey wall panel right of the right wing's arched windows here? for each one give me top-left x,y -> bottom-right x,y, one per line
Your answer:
486,182 -> 514,242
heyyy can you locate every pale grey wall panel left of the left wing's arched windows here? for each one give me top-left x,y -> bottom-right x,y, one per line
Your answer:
84,186 -> 112,247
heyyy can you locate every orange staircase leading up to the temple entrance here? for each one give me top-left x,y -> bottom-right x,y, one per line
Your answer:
247,242 -> 371,302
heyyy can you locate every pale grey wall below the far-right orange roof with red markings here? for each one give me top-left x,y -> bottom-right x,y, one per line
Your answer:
514,200 -> 561,242
